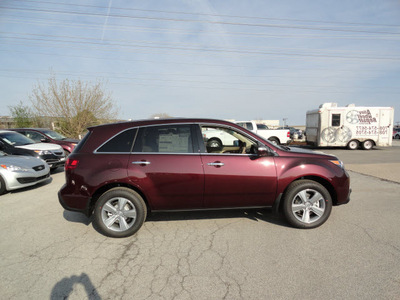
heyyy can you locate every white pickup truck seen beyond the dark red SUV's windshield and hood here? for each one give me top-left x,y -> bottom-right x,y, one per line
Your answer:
234,121 -> 292,145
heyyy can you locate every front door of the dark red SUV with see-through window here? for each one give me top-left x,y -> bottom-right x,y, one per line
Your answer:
201,125 -> 277,208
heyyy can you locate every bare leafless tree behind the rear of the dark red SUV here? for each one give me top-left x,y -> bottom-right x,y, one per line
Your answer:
30,75 -> 118,137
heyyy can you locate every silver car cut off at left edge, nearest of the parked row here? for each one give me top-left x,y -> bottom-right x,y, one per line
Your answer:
0,151 -> 50,195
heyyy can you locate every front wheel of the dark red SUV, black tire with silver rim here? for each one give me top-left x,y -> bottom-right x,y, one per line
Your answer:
283,179 -> 332,229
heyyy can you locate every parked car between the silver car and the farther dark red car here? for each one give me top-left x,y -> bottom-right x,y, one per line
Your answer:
0,130 -> 65,170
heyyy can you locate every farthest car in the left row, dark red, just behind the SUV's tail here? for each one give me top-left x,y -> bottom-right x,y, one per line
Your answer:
10,128 -> 79,156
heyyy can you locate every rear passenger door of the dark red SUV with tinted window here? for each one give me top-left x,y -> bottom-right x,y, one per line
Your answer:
128,124 -> 204,210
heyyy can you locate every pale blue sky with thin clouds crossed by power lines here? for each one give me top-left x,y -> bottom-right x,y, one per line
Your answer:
0,0 -> 400,126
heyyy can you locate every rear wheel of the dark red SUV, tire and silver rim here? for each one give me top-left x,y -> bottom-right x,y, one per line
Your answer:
94,187 -> 147,238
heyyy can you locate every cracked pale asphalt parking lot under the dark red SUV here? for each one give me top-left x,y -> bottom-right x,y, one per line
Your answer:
0,141 -> 400,299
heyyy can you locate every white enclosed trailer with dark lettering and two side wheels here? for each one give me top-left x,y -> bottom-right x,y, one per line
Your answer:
306,103 -> 394,150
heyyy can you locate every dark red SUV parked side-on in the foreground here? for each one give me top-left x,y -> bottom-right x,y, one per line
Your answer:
59,119 -> 350,237
